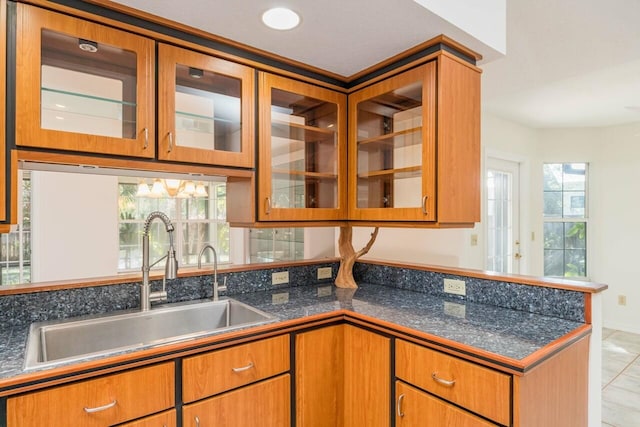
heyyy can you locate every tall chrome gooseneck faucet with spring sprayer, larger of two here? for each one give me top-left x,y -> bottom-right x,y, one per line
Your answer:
140,211 -> 178,311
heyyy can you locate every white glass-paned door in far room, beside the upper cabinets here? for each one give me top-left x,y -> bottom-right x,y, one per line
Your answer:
485,158 -> 522,273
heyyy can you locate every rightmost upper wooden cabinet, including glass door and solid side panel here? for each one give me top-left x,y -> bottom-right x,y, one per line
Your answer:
349,54 -> 480,225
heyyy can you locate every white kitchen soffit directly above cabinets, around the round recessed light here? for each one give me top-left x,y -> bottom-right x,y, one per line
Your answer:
112,0 -> 506,77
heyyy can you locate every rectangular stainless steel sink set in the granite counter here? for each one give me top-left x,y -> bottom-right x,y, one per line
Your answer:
25,299 -> 275,369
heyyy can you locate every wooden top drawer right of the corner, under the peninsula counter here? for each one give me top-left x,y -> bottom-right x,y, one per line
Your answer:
396,340 -> 511,425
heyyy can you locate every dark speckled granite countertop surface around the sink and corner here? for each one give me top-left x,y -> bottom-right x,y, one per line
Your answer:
0,284 -> 584,379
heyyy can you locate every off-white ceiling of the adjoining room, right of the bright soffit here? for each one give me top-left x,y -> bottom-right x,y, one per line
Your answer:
481,0 -> 640,128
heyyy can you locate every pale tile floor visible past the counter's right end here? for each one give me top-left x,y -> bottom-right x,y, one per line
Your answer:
602,328 -> 640,427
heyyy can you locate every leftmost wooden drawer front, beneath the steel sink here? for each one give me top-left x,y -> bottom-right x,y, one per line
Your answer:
7,363 -> 175,427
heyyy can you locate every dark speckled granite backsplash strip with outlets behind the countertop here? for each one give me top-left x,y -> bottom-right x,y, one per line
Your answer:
0,262 -> 586,327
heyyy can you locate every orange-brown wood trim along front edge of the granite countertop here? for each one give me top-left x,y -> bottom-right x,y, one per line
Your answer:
0,309 -> 592,397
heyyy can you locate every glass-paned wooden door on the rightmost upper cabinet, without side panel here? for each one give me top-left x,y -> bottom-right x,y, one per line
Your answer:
349,63 -> 436,224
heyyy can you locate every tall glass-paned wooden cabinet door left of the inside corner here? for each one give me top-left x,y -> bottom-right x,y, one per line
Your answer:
258,73 -> 346,221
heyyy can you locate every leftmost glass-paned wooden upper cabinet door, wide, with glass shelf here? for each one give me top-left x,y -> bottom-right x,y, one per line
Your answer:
16,4 -> 155,157
